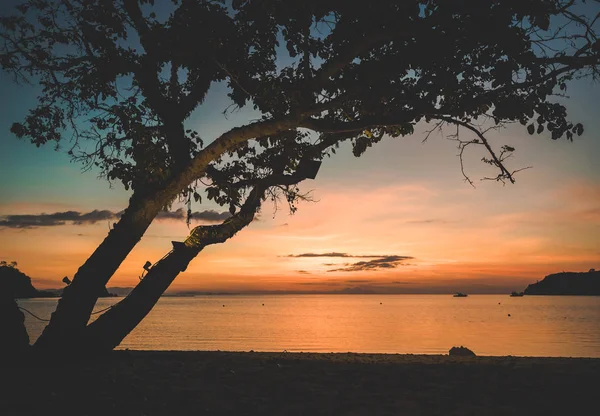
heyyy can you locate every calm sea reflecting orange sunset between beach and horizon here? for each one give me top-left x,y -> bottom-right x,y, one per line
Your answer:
19,295 -> 600,357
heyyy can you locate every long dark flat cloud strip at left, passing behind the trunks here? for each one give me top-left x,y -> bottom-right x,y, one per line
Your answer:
0,208 -> 231,229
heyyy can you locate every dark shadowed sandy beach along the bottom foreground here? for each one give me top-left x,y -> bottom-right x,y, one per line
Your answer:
0,351 -> 600,416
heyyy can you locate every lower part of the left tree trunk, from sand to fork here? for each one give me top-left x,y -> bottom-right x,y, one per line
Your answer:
34,194 -> 168,353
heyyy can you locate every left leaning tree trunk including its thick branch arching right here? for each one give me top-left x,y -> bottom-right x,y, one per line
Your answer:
34,119 -> 301,353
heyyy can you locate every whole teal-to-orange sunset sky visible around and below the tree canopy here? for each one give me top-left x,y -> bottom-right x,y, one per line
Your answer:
0,3 -> 600,293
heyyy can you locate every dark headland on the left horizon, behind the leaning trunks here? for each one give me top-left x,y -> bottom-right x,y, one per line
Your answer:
0,260 -> 117,299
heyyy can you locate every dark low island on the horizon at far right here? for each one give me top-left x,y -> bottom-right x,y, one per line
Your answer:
525,269 -> 600,296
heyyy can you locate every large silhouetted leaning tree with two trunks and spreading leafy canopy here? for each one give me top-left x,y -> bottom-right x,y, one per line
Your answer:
0,0 -> 600,350
